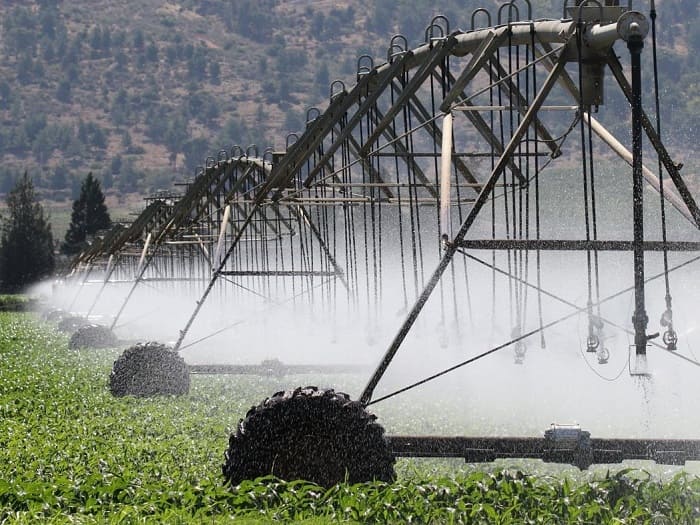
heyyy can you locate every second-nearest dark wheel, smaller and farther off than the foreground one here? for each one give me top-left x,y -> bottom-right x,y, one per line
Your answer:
109,342 -> 190,397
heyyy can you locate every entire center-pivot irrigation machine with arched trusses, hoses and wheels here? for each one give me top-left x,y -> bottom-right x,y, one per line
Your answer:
52,0 -> 700,485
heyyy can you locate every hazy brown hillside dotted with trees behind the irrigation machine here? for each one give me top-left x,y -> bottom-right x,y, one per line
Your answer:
0,0 -> 700,210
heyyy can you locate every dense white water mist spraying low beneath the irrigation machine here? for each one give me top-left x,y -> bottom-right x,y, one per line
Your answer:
34,188 -> 700,437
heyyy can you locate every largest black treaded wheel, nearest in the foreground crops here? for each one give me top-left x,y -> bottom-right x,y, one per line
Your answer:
223,386 -> 395,487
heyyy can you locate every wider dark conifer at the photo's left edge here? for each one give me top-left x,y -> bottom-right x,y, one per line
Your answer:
0,172 -> 55,291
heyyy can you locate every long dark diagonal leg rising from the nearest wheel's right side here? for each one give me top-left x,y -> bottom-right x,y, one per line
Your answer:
360,48 -> 566,405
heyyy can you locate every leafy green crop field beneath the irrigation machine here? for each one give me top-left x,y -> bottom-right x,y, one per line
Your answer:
0,312 -> 700,524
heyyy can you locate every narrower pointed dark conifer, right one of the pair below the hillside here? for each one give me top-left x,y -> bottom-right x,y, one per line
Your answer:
61,173 -> 112,255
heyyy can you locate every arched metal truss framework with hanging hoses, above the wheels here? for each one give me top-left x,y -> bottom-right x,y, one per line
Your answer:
67,0 -> 700,462
